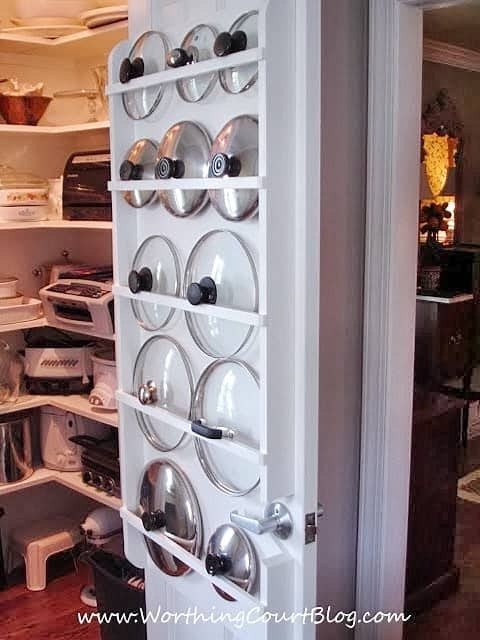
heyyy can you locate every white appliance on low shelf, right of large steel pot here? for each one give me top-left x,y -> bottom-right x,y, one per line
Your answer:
40,406 -> 105,471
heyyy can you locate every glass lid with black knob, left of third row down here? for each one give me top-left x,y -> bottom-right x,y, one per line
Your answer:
128,236 -> 180,331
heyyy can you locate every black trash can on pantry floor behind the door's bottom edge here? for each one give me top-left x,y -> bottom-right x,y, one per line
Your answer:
83,549 -> 147,640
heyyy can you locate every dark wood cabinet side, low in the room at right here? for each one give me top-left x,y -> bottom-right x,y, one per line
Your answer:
405,390 -> 464,613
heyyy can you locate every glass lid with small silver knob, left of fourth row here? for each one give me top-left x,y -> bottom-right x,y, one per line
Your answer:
133,336 -> 193,451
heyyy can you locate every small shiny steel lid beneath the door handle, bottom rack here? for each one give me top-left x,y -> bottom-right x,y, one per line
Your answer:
205,524 -> 257,601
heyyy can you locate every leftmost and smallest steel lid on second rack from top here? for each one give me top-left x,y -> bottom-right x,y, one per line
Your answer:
119,138 -> 157,209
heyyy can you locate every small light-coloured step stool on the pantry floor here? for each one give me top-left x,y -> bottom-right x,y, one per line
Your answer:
8,516 -> 82,591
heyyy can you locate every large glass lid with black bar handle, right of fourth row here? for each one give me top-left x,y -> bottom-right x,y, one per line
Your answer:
192,359 -> 260,496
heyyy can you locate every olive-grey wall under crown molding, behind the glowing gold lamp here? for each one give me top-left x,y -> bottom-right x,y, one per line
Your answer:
423,62 -> 480,244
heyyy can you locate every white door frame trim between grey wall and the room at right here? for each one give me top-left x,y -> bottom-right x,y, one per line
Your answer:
355,0 -> 463,640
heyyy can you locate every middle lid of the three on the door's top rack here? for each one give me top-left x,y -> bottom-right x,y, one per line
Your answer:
167,24 -> 217,102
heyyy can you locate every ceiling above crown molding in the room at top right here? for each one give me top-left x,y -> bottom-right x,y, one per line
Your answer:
423,0 -> 480,51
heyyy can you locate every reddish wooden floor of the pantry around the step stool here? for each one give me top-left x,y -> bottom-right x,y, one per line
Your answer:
0,564 -> 100,640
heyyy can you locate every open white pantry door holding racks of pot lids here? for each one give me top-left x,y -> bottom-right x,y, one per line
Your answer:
109,0 -> 320,640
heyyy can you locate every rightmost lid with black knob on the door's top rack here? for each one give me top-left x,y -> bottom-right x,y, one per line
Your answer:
214,11 -> 258,93
